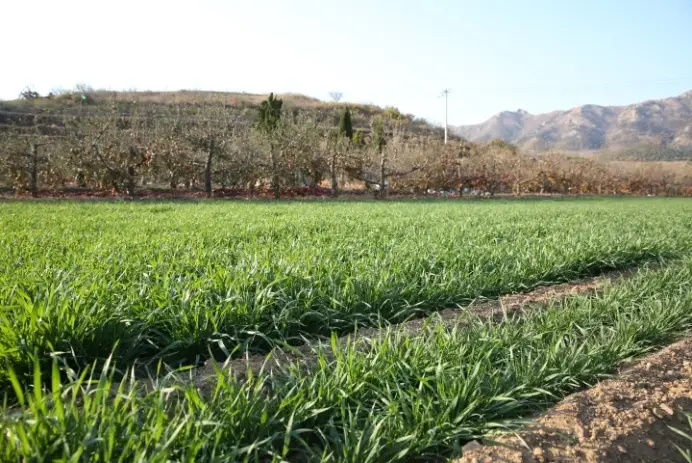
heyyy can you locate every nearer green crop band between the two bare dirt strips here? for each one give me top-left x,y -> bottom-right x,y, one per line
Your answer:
0,259 -> 692,462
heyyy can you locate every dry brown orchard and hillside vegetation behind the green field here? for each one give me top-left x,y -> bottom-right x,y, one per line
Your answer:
0,91 -> 692,198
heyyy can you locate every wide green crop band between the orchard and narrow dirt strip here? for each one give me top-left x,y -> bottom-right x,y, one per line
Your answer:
0,199 -> 692,388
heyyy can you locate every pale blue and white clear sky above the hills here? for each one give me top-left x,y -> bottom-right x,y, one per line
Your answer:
0,0 -> 692,125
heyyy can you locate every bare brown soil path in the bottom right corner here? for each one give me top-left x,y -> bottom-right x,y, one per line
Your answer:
457,338 -> 692,463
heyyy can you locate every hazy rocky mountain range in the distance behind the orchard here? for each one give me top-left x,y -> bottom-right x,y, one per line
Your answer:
452,90 -> 692,152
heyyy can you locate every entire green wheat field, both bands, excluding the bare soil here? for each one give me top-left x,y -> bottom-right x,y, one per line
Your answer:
0,198 -> 692,462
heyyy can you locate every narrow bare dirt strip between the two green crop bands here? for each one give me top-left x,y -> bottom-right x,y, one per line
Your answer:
197,264 -> 644,390
